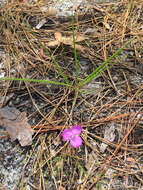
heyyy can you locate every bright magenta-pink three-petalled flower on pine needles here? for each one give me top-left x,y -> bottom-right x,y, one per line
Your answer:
62,125 -> 82,148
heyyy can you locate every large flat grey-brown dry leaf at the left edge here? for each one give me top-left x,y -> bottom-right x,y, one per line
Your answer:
0,106 -> 34,146
